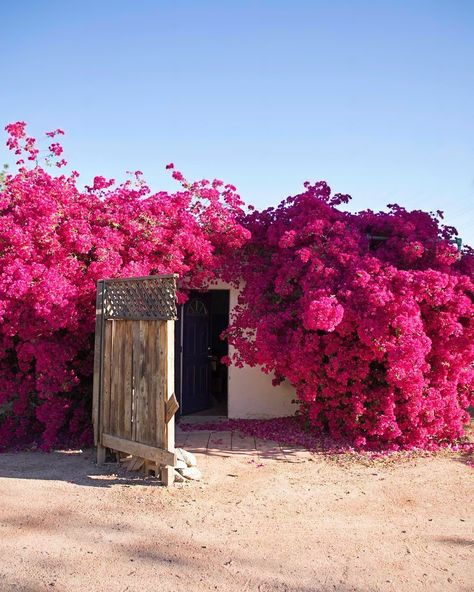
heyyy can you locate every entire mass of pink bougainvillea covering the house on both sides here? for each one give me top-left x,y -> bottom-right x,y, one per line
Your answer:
0,122 -> 474,450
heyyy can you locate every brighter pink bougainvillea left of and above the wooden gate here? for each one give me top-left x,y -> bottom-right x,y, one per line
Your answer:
0,122 -> 249,448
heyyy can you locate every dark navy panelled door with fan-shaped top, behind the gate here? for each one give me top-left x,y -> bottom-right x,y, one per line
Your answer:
181,294 -> 211,414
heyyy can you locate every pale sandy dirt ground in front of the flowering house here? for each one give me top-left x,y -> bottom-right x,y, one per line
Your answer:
0,433 -> 474,592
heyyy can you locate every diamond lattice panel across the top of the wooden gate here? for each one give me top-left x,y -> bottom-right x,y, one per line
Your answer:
104,275 -> 177,321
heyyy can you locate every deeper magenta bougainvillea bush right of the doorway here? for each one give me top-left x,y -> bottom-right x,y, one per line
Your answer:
223,182 -> 474,450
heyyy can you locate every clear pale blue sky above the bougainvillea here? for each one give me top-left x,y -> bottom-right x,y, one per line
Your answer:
0,0 -> 474,244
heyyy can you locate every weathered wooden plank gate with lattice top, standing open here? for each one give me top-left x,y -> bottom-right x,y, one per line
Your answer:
92,275 -> 178,484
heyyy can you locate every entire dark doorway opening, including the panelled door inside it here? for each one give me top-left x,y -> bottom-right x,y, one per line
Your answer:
176,290 -> 229,416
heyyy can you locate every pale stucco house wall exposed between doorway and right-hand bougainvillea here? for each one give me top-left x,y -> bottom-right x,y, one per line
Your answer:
211,282 -> 297,419
